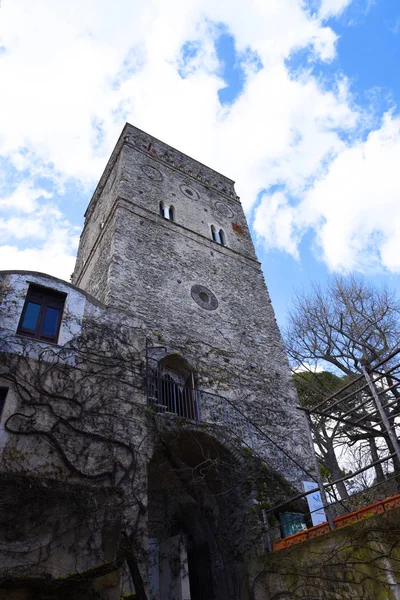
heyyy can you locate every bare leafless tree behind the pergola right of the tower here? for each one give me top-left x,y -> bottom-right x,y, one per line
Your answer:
285,275 -> 400,490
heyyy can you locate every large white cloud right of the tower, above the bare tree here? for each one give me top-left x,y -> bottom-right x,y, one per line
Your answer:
256,113 -> 400,272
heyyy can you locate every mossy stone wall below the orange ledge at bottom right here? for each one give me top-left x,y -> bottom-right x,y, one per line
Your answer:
245,508 -> 400,600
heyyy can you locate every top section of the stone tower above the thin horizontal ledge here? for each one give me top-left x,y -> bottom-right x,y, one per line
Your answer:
73,125 -> 256,287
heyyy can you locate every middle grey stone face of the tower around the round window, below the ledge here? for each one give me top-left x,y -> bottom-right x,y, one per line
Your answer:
107,204 -> 307,480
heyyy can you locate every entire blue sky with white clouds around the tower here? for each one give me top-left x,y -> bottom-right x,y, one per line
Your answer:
0,0 -> 400,325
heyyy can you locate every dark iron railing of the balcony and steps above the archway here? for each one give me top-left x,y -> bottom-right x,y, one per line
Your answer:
147,373 -> 255,449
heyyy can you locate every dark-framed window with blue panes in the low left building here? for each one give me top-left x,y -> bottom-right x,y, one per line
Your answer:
17,285 -> 66,343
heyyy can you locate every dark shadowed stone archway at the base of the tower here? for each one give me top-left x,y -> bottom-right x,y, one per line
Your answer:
148,428 -> 252,600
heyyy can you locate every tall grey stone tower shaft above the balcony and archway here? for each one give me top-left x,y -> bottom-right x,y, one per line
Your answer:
72,124 -> 309,486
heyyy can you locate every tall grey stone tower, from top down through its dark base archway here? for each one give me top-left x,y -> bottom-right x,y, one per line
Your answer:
72,124 -> 309,600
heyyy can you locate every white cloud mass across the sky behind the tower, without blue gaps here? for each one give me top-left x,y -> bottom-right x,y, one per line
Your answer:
0,0 -> 400,278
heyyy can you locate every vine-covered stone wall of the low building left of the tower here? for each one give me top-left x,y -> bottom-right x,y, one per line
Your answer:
0,271 -> 152,600
